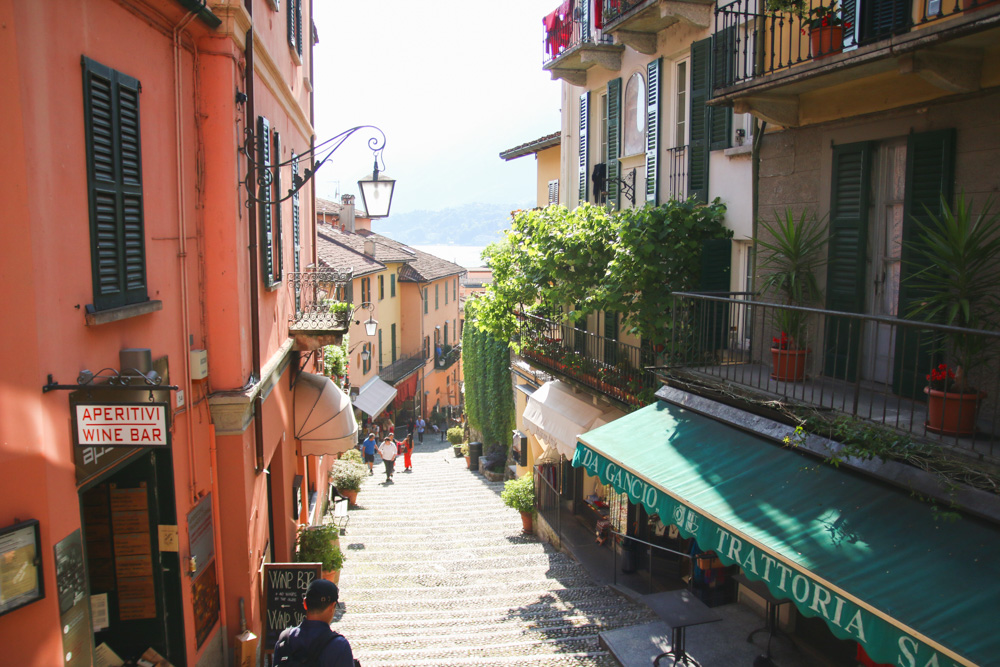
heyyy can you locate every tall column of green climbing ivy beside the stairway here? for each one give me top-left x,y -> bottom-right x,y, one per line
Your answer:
462,299 -> 515,447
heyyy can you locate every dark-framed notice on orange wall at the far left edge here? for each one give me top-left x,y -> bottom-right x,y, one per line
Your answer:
0,519 -> 45,615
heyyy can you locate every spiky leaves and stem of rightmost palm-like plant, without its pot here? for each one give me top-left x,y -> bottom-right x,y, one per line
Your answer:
907,193 -> 1000,393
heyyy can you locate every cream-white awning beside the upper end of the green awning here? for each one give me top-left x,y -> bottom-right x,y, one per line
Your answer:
524,380 -> 602,459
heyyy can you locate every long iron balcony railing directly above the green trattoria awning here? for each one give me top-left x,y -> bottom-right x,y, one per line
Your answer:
665,293 -> 1000,456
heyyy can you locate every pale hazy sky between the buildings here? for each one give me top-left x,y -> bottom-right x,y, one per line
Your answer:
313,0 -> 559,213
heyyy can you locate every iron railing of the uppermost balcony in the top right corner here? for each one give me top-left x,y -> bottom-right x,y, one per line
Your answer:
713,0 -> 993,89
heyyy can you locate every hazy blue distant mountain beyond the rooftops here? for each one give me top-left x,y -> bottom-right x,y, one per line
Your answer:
372,204 -> 532,246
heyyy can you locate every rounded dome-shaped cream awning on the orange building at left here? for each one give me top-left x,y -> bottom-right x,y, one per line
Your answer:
294,372 -> 358,456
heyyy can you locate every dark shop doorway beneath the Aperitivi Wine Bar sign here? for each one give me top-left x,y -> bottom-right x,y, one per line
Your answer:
80,450 -> 186,667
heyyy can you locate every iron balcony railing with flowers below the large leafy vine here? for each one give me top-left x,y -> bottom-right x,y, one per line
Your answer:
519,314 -> 659,406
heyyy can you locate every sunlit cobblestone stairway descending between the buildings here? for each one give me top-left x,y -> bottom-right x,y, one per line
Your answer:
333,436 -> 653,667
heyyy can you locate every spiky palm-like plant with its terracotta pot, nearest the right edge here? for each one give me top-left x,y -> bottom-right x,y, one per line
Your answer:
906,194 -> 1000,435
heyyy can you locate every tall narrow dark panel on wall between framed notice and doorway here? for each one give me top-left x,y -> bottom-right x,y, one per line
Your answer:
54,528 -> 93,667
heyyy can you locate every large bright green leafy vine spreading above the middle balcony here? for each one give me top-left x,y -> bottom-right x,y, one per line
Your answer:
476,199 -> 732,350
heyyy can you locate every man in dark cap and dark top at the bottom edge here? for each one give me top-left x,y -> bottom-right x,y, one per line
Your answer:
273,578 -> 355,667
